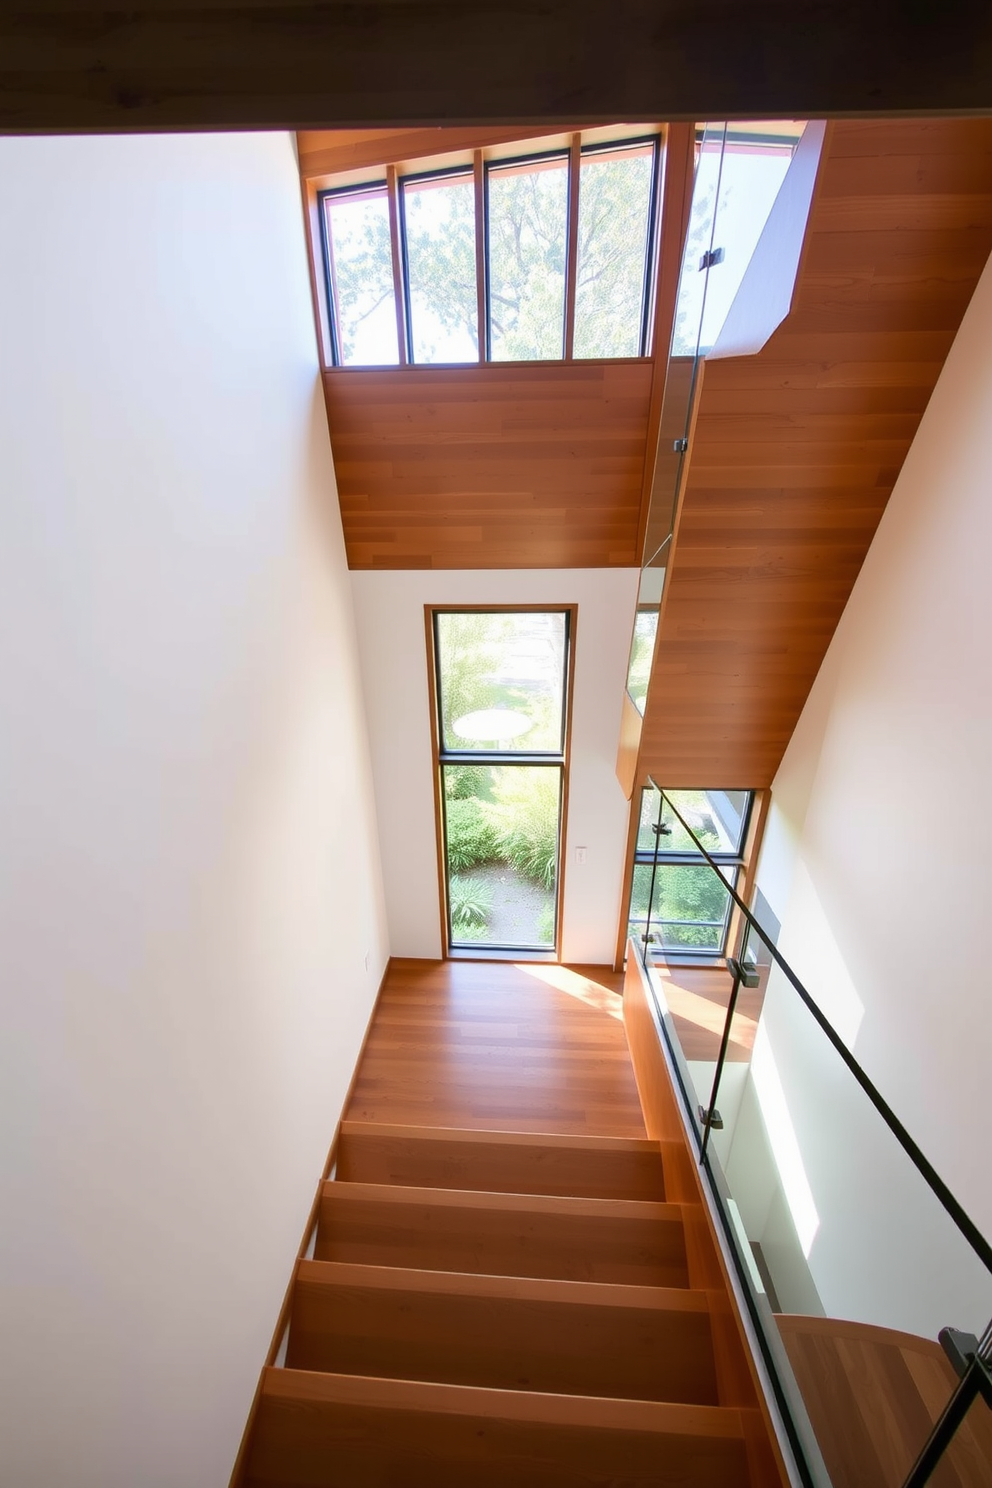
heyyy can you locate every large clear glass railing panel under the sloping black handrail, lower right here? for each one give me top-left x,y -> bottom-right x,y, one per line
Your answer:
725,934 -> 992,1488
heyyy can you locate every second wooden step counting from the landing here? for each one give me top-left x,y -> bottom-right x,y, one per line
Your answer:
314,1180 -> 689,1287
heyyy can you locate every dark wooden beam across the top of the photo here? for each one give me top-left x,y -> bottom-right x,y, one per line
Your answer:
0,0 -> 992,132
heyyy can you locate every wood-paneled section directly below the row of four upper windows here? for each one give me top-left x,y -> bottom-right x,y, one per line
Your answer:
324,362 -> 651,568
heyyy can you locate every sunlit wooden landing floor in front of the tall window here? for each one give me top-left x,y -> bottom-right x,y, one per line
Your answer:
345,960 -> 645,1137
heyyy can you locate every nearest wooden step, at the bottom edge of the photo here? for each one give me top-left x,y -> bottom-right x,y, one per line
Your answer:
245,1369 -> 748,1488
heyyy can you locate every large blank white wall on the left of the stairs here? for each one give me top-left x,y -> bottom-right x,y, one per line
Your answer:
0,135 -> 387,1488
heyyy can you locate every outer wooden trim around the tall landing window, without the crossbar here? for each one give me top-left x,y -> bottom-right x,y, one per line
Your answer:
424,600 -> 579,961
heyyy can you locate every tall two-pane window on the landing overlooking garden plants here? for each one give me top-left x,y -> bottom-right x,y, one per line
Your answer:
430,609 -> 574,954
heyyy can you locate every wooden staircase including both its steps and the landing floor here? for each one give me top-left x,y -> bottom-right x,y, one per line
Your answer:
232,961 -> 787,1488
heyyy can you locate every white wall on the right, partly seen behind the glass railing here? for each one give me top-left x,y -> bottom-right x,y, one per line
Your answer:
743,244 -> 992,1332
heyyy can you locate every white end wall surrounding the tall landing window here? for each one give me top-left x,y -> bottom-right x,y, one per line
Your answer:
351,568 -> 638,963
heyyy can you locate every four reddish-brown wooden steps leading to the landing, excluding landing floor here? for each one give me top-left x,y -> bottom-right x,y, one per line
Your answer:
237,1120 -> 772,1488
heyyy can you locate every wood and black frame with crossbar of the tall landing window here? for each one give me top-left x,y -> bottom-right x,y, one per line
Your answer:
424,603 -> 579,961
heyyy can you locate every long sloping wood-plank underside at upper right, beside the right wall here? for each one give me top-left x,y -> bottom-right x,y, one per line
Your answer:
638,119 -> 992,787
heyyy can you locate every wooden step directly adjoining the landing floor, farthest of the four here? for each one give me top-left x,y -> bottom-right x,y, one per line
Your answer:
336,1120 -> 665,1202
